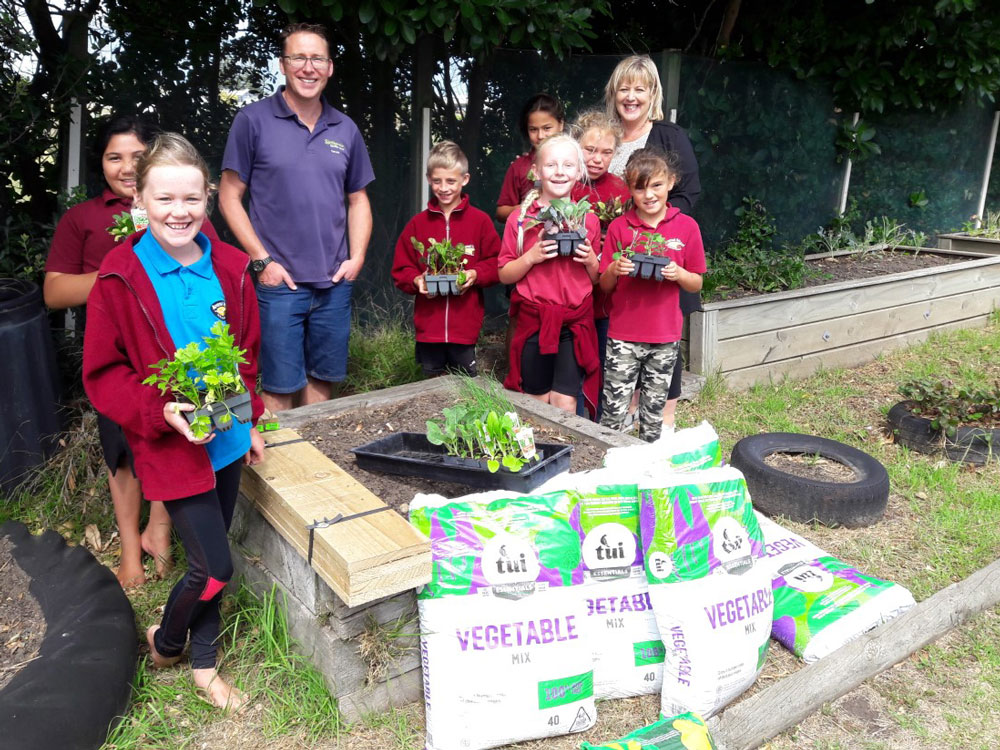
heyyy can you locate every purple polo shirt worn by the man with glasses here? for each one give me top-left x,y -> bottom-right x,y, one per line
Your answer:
222,86 -> 375,287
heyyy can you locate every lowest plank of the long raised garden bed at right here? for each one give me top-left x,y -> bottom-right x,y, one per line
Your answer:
722,315 -> 990,388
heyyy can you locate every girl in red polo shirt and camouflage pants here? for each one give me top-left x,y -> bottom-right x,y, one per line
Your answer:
600,148 -> 706,442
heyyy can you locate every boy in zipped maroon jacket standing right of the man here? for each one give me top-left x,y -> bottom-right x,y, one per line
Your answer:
392,141 -> 500,376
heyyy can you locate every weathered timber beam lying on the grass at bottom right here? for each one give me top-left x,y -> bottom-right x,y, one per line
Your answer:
708,560 -> 1000,750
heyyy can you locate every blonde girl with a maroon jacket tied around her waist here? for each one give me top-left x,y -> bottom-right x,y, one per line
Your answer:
498,134 -> 601,414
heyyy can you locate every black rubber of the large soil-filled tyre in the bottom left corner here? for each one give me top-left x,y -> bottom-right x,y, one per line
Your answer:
0,521 -> 137,750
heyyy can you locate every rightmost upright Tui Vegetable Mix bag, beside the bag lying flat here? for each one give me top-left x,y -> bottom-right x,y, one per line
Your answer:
639,467 -> 773,716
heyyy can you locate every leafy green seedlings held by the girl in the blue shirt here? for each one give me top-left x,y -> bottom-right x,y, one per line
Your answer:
142,320 -> 247,440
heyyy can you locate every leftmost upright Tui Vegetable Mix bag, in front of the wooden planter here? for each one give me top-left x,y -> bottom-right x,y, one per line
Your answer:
410,492 -> 595,750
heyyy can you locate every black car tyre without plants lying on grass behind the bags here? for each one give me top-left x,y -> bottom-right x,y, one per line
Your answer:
731,432 -> 889,528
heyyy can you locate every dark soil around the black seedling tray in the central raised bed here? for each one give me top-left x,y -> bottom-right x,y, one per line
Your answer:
299,393 -> 606,515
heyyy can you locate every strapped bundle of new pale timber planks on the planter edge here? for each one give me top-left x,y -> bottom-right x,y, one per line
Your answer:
242,428 -> 431,606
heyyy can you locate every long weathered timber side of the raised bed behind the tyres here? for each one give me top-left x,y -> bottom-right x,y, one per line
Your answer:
687,247 -> 1000,388
